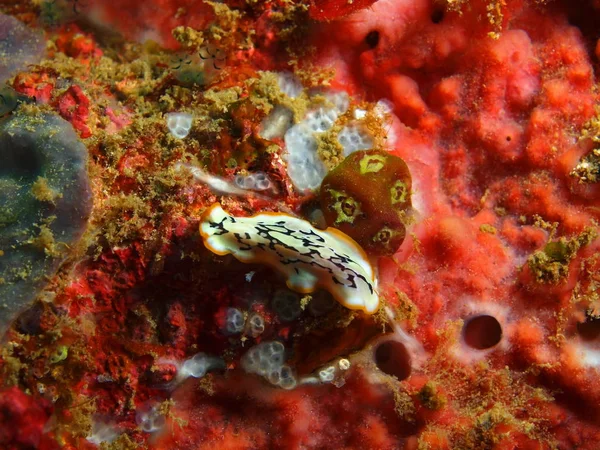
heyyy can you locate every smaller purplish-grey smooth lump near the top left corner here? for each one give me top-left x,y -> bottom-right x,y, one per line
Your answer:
0,14 -> 46,83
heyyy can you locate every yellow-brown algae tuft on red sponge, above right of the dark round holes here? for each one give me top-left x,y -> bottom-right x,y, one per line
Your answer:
527,228 -> 598,284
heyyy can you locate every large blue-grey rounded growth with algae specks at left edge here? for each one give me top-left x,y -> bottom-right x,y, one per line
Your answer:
0,114 -> 92,335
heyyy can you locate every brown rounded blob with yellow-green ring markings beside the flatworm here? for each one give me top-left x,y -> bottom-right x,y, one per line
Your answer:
320,150 -> 412,255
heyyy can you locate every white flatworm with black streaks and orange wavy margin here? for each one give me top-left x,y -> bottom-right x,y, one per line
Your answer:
200,203 -> 379,314
